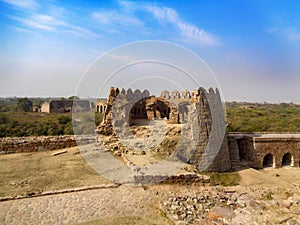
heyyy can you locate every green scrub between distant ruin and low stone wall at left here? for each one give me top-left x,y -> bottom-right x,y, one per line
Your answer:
0,112 -> 102,137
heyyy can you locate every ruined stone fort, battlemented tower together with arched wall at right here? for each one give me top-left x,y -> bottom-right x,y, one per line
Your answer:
97,87 -> 300,172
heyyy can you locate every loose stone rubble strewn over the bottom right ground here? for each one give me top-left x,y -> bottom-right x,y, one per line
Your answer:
160,187 -> 300,225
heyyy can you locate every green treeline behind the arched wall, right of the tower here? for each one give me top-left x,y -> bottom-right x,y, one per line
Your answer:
226,102 -> 300,132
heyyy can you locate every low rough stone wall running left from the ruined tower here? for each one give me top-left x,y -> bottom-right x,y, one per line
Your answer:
0,136 -> 96,154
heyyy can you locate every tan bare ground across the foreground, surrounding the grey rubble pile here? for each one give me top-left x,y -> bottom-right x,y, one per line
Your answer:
0,148 -> 300,225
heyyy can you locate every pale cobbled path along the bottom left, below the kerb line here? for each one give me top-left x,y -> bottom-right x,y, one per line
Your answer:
0,185 -> 163,225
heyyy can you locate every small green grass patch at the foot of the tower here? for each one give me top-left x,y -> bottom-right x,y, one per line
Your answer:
204,172 -> 241,186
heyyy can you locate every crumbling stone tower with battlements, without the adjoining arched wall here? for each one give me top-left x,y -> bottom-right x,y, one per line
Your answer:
98,87 -> 231,172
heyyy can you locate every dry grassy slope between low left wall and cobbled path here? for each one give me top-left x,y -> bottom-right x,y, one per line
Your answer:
0,147 -> 109,196
